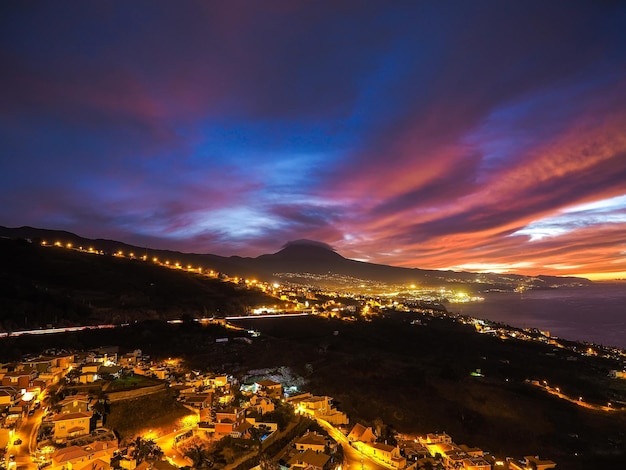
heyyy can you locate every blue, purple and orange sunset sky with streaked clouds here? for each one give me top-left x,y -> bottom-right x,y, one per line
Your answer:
0,0 -> 626,279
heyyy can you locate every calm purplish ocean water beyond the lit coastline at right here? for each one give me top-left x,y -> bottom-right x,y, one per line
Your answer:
448,282 -> 626,349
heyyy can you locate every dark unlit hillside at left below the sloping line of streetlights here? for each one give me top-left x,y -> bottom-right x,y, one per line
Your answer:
0,239 -> 271,331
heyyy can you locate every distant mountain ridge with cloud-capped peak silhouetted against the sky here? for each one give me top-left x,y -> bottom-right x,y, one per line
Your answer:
0,226 -> 591,290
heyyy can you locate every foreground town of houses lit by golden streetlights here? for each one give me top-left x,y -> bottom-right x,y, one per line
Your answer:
0,346 -> 556,470
